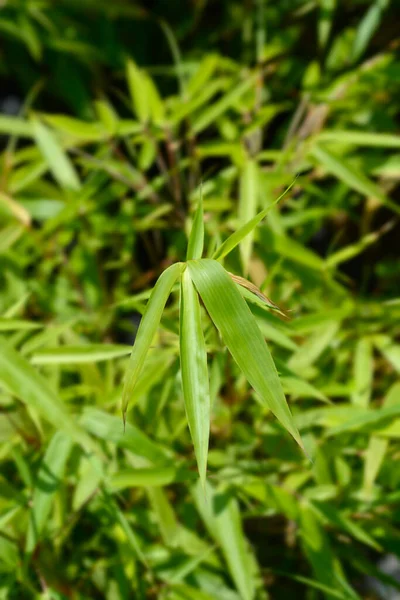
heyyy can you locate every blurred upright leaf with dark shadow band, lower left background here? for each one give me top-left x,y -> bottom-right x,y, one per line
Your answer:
26,431 -> 72,553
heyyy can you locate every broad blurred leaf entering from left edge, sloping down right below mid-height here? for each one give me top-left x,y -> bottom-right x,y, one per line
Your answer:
0,340 -> 91,446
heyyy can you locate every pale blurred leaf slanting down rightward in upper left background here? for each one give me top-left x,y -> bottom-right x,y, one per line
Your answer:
32,119 -> 81,190
